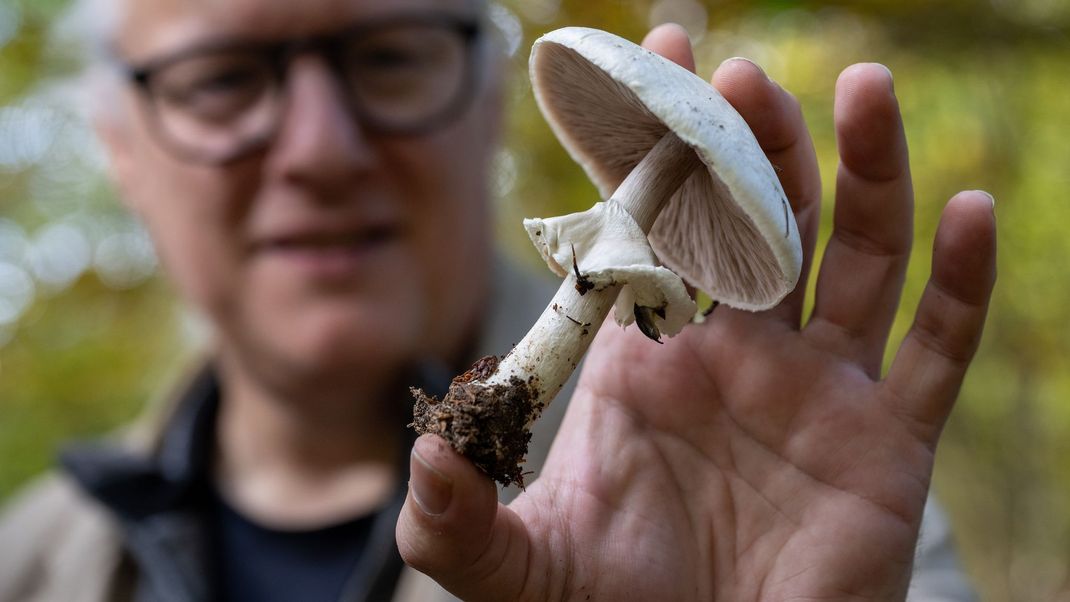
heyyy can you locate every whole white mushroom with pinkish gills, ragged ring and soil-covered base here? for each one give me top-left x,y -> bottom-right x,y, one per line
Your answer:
413,28 -> 803,485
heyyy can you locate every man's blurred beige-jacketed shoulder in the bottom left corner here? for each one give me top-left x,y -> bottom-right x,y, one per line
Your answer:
0,474 -> 121,602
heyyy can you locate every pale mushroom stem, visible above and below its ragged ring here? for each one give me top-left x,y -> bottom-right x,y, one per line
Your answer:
484,132 -> 702,404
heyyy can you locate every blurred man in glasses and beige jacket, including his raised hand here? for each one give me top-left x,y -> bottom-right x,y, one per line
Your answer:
0,0 -> 994,600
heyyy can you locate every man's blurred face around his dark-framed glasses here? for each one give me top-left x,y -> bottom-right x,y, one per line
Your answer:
105,0 -> 499,391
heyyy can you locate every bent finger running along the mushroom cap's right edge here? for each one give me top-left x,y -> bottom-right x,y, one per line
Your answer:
714,59 -> 821,327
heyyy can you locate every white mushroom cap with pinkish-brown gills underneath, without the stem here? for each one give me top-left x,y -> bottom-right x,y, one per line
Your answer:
530,27 -> 803,310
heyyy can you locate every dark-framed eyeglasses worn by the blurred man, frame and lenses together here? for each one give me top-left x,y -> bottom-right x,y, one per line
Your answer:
120,14 -> 479,164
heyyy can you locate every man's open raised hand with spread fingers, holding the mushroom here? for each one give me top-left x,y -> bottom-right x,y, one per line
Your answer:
398,22 -> 995,600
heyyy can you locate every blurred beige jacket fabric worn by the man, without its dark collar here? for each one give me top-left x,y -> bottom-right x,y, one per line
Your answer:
0,261 -> 973,602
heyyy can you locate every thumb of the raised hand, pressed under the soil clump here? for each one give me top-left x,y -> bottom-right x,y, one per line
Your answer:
397,435 -> 529,600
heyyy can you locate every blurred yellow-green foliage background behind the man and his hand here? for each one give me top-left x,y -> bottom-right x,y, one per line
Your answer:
0,0 -> 1070,601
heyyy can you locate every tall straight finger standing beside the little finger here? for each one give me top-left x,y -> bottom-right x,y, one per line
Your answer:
807,63 -> 914,379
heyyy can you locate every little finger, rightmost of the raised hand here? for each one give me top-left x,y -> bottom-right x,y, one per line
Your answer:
883,191 -> 996,441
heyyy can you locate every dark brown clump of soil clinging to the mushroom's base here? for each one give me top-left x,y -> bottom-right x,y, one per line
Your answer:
410,357 -> 542,488
